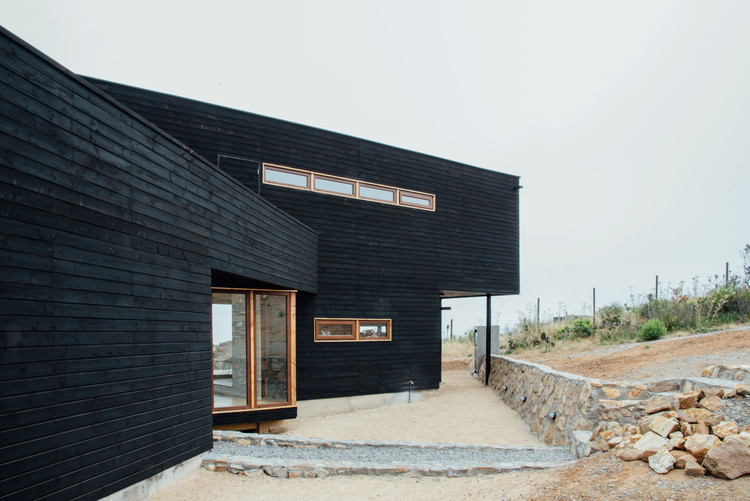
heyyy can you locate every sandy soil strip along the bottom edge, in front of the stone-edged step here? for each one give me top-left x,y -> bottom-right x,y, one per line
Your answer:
151,453 -> 750,501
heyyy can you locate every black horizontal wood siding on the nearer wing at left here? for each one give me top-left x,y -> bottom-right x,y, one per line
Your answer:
0,30 -> 317,499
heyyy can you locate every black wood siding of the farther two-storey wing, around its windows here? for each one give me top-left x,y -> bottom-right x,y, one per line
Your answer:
92,79 -> 519,400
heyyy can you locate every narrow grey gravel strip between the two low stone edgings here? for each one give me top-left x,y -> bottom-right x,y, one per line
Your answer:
211,437 -> 576,465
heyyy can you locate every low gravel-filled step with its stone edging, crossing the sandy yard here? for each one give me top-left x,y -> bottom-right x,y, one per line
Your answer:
203,432 -> 576,478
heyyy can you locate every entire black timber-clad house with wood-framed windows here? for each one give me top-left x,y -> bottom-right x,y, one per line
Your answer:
0,31 -> 519,499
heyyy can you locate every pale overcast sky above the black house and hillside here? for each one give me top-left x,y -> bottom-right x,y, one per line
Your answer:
0,0 -> 750,333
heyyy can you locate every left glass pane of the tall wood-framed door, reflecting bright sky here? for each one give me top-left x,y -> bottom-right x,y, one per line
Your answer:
211,293 -> 248,408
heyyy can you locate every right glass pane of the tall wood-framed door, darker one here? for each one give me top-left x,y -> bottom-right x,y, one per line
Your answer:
255,293 -> 289,405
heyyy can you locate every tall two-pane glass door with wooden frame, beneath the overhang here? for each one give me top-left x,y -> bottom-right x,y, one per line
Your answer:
211,289 -> 295,412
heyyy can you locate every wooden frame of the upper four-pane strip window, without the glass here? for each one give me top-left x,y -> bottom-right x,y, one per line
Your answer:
263,163 -> 436,212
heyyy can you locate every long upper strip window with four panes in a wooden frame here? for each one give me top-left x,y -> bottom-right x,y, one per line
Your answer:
263,163 -> 435,211
